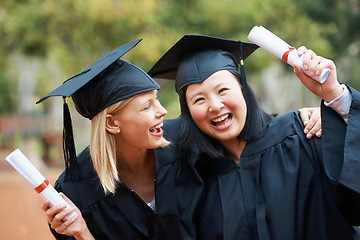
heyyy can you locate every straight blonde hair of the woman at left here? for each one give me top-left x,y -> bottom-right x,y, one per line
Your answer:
90,97 -> 170,194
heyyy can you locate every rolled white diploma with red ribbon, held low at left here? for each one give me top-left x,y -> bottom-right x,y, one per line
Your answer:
5,149 -> 76,220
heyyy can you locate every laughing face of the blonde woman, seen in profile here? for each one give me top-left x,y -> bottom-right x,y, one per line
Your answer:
113,90 -> 167,149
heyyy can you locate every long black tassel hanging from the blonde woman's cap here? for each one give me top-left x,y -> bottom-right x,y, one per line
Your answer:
63,97 -> 81,182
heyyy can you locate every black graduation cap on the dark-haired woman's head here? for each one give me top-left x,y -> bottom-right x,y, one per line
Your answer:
148,34 -> 259,92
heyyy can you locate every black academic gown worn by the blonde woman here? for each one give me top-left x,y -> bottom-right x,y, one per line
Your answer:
52,120 -> 203,240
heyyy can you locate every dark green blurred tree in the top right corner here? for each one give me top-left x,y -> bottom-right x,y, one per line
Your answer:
297,0 -> 360,89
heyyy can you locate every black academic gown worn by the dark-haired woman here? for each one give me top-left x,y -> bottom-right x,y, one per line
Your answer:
197,85 -> 360,240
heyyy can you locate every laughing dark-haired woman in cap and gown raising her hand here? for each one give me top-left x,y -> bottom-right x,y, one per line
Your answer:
149,35 -> 360,240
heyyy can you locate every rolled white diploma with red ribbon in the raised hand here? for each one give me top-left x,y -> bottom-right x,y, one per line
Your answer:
248,26 -> 330,83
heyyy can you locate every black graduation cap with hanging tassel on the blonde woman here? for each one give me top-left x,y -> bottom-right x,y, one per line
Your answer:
36,39 -> 160,181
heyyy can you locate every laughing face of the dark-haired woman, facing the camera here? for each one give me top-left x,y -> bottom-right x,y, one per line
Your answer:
186,70 -> 247,142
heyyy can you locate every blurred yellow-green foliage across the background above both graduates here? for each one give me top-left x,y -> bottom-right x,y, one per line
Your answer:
0,0 -> 360,115
